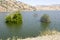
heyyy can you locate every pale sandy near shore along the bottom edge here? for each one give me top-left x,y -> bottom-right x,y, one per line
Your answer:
0,31 -> 60,40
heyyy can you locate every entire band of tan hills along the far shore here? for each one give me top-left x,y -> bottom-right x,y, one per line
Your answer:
0,0 -> 60,12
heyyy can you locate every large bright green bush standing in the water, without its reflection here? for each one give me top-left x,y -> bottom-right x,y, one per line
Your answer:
6,11 -> 22,24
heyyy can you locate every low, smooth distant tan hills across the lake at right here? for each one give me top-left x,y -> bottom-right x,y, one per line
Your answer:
35,4 -> 60,10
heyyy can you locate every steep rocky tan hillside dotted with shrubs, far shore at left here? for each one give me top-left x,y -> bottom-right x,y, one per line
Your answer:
0,0 -> 36,12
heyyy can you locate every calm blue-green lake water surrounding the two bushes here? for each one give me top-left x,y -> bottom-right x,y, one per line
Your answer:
0,11 -> 60,40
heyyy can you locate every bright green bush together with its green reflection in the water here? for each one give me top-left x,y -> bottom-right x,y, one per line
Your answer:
5,12 -> 22,30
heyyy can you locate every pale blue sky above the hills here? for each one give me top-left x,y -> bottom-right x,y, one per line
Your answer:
17,0 -> 60,6
